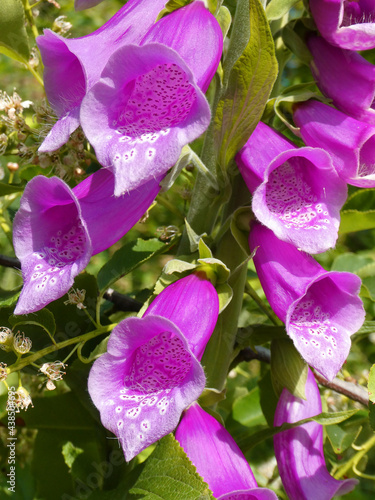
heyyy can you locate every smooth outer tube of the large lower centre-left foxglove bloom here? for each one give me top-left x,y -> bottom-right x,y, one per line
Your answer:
144,273 -> 219,360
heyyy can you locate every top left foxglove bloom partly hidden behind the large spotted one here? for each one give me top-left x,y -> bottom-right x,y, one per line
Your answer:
37,0 -> 166,152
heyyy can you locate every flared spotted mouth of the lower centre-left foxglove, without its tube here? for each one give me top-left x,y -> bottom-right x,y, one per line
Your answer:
88,315 -> 205,461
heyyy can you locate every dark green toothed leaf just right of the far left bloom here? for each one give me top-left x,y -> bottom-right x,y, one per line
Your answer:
98,238 -> 173,293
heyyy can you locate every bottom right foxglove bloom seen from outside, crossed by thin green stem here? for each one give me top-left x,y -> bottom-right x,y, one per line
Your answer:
273,370 -> 358,500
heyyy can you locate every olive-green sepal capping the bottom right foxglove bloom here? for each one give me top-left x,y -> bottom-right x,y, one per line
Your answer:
271,339 -> 308,399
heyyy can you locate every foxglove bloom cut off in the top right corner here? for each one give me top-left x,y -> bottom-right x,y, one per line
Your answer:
309,0 -> 375,50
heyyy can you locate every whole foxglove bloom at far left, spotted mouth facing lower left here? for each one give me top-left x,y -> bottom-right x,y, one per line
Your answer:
13,169 -> 160,314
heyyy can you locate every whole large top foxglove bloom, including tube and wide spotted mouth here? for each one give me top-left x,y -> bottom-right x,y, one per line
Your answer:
80,2 -> 222,196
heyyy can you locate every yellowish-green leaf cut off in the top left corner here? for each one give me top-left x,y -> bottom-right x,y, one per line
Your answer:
0,0 -> 30,63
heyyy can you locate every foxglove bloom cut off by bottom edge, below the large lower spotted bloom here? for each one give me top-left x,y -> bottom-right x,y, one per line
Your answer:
176,403 -> 277,500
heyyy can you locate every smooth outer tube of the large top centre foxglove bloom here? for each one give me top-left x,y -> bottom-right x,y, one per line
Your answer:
141,1 -> 223,92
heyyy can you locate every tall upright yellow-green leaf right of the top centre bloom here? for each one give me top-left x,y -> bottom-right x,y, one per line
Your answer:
214,0 -> 277,170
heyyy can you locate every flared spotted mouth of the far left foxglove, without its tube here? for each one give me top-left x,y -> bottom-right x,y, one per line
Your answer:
13,176 -> 92,314
